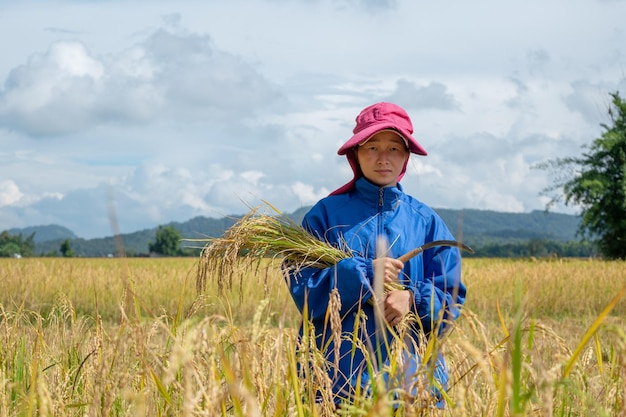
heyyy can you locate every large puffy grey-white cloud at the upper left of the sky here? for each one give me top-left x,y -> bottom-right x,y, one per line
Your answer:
0,29 -> 279,136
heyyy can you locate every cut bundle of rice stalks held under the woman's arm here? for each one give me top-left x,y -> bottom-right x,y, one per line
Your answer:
196,202 -> 352,294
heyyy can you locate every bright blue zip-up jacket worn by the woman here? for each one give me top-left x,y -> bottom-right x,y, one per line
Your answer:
289,178 -> 465,397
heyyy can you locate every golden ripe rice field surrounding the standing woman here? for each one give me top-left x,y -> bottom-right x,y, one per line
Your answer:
0,258 -> 626,416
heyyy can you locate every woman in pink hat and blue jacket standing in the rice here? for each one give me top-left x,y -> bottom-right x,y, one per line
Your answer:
282,102 -> 466,408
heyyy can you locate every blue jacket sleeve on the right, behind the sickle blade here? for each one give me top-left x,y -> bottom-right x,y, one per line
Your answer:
412,216 -> 466,334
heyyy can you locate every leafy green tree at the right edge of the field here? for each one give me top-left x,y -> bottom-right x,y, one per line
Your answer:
538,92 -> 626,259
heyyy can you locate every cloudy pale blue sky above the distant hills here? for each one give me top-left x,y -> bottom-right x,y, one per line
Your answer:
0,0 -> 626,239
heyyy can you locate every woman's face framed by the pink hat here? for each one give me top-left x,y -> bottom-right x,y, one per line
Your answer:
356,130 -> 409,187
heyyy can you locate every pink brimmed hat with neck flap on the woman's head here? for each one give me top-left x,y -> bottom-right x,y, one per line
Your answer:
330,102 -> 427,195
